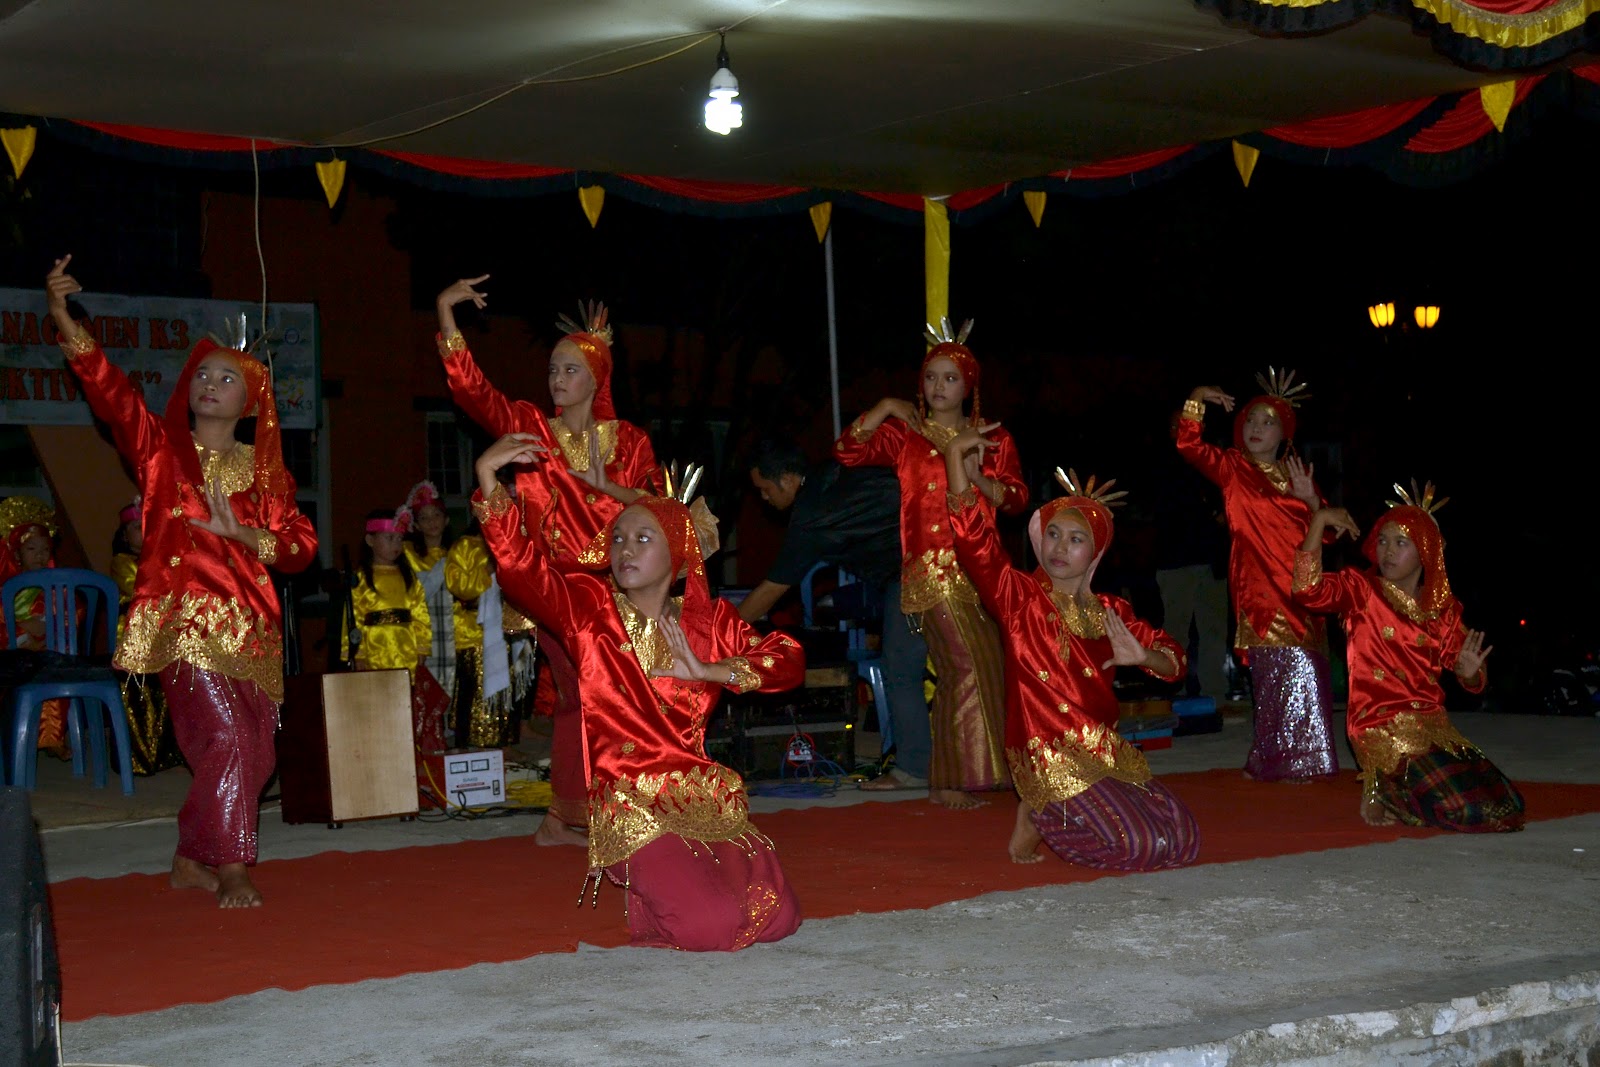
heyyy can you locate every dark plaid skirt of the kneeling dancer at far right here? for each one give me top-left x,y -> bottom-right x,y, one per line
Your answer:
1368,745 -> 1523,833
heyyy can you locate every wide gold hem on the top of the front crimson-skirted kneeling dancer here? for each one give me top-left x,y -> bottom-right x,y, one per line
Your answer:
589,765 -> 755,870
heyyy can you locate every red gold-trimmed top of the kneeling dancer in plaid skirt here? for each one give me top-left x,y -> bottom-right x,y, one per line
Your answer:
1293,550 -> 1486,773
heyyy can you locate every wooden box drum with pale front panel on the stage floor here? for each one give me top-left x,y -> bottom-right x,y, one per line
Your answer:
278,670 -> 418,829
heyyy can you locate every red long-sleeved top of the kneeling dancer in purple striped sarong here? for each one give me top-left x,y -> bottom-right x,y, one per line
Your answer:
947,491 -> 1187,811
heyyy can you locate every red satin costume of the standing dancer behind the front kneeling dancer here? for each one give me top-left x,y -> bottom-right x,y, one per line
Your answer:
438,331 -> 662,827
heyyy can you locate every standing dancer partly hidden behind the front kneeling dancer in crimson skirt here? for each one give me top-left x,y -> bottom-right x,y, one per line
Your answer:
437,274 -> 661,845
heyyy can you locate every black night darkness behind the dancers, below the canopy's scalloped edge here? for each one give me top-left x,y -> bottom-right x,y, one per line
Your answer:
0,112 -> 1600,710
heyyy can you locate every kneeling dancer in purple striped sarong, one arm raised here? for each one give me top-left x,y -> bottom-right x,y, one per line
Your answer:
944,441 -> 1200,870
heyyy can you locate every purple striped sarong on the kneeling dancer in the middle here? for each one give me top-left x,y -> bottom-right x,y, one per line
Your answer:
1034,777 -> 1200,870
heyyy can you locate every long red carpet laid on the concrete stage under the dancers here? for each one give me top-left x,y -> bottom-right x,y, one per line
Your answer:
50,769 -> 1600,1021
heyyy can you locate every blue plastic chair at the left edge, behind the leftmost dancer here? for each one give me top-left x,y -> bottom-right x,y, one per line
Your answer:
0,566 -> 133,797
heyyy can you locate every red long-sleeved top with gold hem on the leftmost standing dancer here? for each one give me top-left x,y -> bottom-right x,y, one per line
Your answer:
70,346 -> 317,702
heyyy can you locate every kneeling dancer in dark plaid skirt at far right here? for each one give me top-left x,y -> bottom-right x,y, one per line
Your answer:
1294,482 -> 1523,832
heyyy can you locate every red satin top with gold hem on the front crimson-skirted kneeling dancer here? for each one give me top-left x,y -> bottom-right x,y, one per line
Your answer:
474,493 -> 805,869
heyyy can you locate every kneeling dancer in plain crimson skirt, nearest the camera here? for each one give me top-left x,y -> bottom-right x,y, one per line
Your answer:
472,434 -> 805,952
